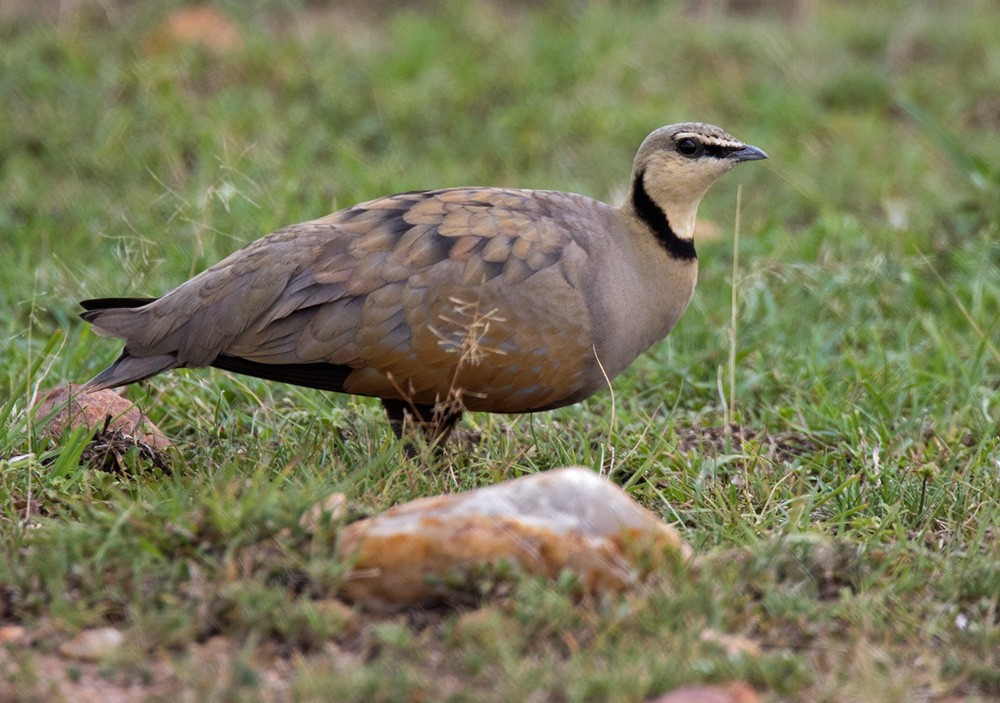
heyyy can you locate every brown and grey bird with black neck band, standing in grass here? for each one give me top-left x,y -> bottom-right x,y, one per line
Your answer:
80,122 -> 767,446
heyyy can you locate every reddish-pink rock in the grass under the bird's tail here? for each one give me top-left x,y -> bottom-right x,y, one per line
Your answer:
34,383 -> 170,451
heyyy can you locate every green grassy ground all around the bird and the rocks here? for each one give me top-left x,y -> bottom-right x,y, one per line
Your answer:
0,0 -> 1000,701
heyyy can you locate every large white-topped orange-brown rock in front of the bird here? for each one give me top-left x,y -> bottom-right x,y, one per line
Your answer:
337,468 -> 690,608
